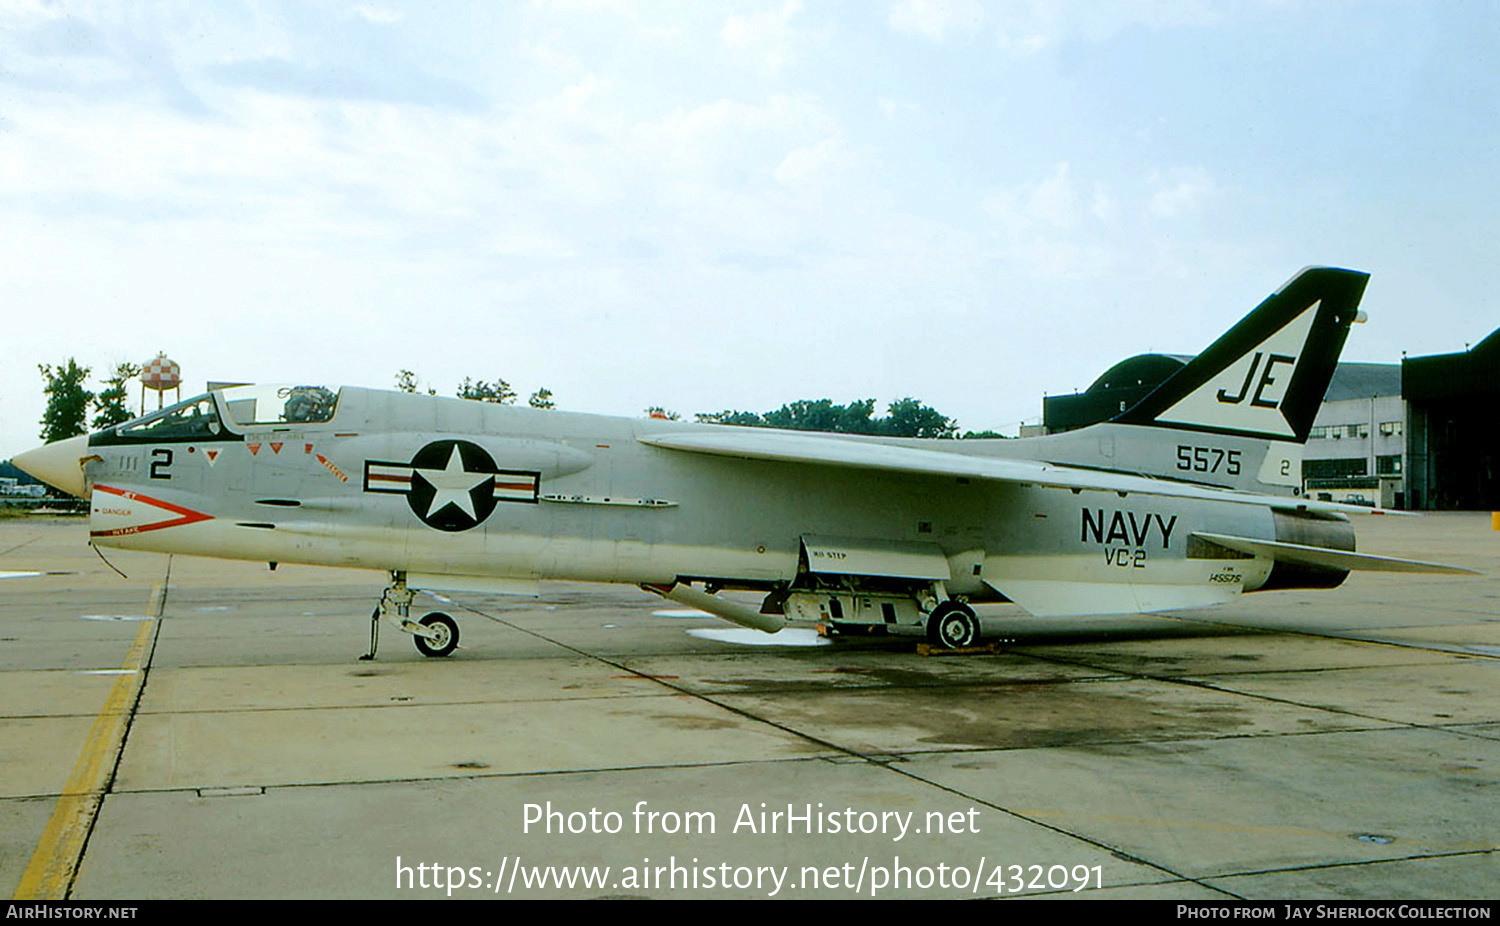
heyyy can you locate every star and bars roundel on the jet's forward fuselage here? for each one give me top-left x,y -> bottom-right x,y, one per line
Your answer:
365,440 -> 542,531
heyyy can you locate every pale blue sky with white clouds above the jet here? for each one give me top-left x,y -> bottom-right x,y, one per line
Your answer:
0,0 -> 1500,458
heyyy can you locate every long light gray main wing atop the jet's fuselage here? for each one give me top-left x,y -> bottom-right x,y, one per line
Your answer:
638,428 -> 1407,516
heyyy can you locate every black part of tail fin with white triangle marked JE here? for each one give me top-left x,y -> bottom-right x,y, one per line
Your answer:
1113,267 -> 1370,444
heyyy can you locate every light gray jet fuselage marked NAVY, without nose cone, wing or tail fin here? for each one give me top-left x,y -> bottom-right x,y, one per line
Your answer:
49,387 -> 1338,611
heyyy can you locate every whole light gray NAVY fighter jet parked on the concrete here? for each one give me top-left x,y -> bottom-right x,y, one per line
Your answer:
14,267 -> 1466,657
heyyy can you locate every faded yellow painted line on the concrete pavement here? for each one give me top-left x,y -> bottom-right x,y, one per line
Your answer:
14,582 -> 167,900
